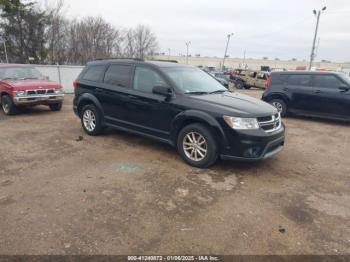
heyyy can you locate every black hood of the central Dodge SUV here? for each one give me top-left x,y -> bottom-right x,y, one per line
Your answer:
191,92 -> 277,117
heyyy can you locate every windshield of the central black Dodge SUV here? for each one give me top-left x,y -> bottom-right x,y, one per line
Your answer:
162,67 -> 226,94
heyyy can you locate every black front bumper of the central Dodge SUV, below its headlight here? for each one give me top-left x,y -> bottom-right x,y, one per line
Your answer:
220,124 -> 285,161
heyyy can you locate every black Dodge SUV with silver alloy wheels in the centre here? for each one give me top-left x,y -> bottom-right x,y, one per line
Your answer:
74,59 -> 284,168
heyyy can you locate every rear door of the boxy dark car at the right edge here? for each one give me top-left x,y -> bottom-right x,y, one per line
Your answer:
283,74 -> 314,112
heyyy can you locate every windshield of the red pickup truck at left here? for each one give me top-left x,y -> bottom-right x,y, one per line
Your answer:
0,67 -> 43,80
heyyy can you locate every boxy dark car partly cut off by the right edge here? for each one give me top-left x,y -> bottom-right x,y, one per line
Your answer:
262,71 -> 350,120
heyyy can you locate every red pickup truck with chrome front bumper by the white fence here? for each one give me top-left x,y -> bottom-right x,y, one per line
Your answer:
0,64 -> 64,115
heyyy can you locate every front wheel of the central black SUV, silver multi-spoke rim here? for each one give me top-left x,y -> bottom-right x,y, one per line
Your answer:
177,124 -> 218,168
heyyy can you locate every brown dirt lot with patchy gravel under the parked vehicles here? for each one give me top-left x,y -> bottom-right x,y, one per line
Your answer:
0,90 -> 350,254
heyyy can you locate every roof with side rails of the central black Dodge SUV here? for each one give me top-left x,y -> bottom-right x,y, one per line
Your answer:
87,59 -> 193,68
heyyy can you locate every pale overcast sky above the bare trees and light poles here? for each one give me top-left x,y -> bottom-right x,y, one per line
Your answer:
52,0 -> 350,61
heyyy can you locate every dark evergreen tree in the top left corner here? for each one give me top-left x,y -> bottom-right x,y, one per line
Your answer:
0,0 -> 48,63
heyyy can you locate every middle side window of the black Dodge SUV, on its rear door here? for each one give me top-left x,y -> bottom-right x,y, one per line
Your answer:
104,65 -> 131,87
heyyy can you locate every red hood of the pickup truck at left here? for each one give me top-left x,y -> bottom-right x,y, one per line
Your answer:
2,79 -> 62,91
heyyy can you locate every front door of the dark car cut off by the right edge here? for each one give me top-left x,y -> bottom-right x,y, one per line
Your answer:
313,74 -> 350,118
